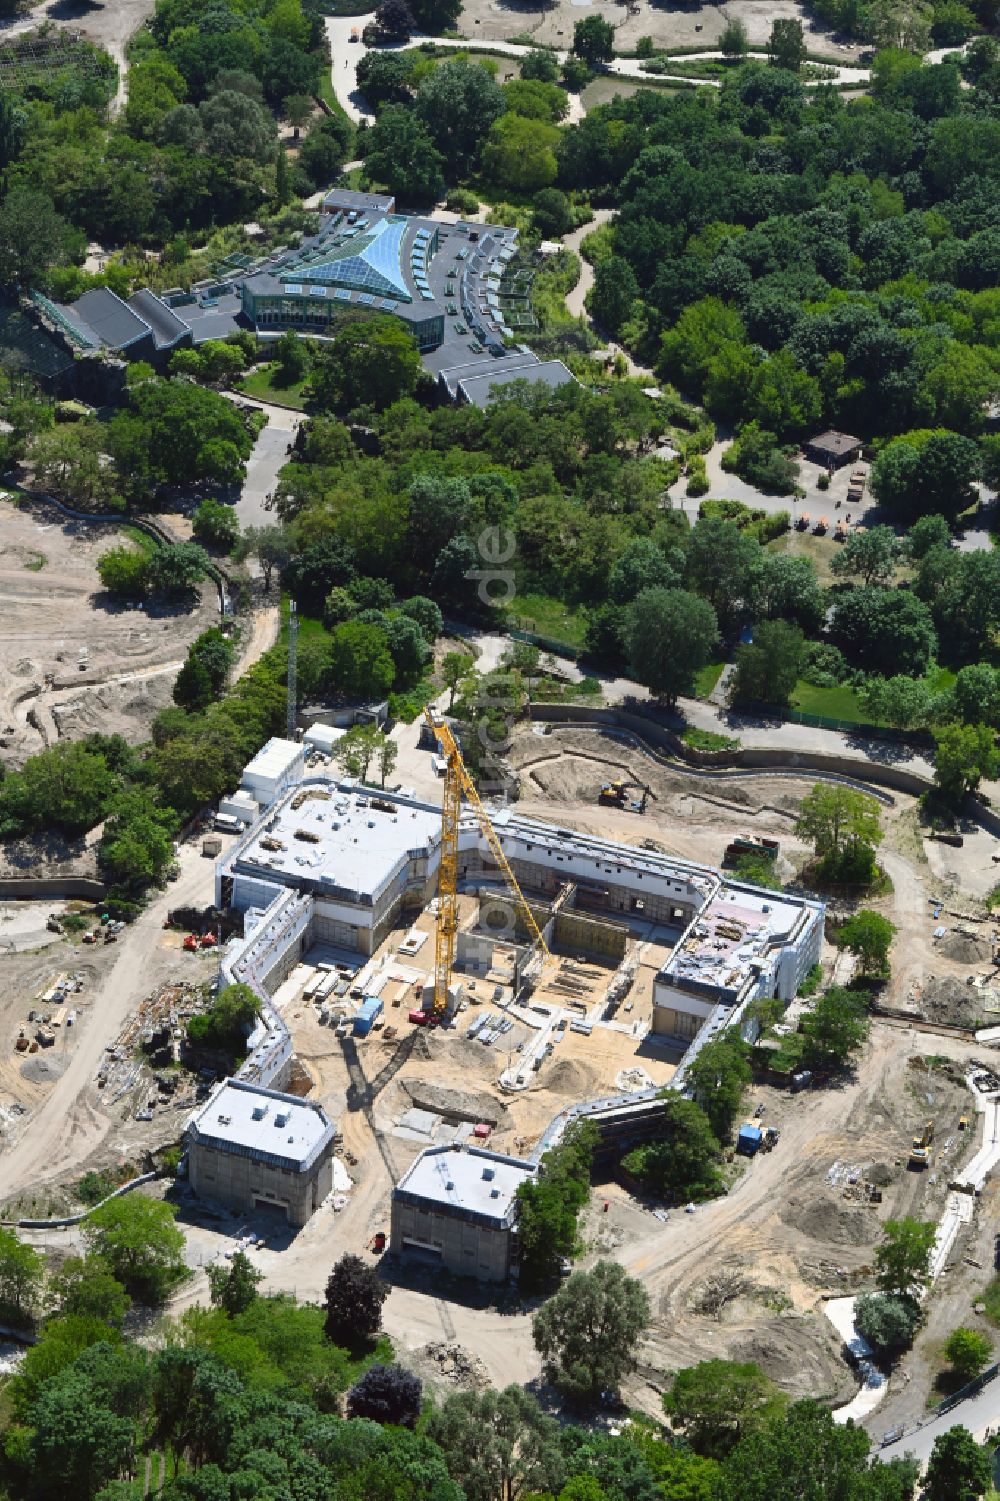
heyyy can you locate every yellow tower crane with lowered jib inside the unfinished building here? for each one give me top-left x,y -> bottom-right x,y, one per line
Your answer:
423,708 -> 548,1016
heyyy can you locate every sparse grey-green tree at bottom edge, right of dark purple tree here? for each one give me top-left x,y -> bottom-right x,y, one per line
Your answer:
426,1385 -> 566,1501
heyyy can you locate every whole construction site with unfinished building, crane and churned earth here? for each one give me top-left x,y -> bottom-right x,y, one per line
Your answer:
0,708 -> 1000,1432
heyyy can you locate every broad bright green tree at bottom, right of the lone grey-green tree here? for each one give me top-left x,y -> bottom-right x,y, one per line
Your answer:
664,1360 -> 788,1459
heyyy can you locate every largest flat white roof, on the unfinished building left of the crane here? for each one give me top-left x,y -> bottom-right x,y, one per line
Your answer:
236,778 -> 441,898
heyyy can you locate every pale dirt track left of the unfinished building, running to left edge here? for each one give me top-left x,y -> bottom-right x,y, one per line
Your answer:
0,841 -> 213,1199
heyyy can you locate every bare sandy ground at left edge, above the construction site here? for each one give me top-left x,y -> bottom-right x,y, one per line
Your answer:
0,504 -> 218,766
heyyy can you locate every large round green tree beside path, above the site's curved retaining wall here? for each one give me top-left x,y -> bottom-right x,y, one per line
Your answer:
623,588 -> 719,704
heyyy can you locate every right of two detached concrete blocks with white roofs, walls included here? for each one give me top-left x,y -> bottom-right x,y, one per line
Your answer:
390,1147 -> 538,1282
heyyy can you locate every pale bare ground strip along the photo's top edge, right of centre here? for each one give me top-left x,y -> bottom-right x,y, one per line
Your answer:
458,0 -> 859,62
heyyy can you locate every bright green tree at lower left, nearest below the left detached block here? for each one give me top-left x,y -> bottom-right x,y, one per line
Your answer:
84,1193 -> 188,1303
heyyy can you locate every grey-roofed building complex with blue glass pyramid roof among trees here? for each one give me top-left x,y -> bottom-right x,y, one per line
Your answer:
23,189 -> 574,405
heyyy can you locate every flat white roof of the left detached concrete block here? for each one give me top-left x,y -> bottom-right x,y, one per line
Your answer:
188,1079 -> 333,1172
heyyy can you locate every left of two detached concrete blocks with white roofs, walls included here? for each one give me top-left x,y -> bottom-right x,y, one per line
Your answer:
185,1079 -> 335,1225
